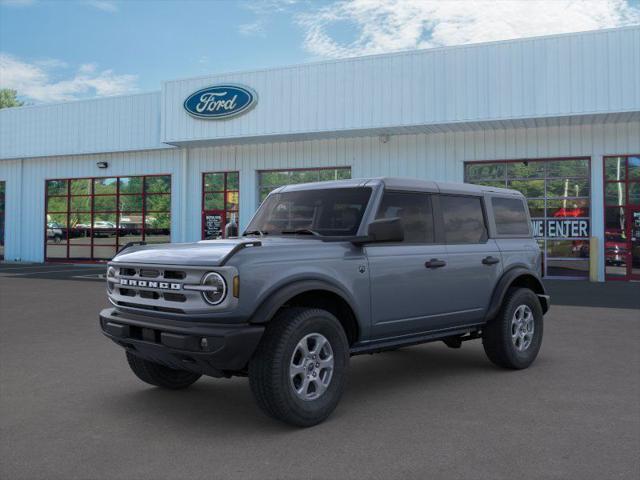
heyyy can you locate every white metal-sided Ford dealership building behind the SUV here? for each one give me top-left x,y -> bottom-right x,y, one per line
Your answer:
0,27 -> 640,281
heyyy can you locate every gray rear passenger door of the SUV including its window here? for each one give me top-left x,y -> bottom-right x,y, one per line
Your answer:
439,194 -> 502,326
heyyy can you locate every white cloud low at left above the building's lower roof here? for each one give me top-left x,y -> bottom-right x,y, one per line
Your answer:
0,53 -> 138,102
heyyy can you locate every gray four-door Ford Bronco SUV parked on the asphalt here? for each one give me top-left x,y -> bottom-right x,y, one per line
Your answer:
100,178 -> 549,426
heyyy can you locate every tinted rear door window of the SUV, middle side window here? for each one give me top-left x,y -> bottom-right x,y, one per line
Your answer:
440,195 -> 488,243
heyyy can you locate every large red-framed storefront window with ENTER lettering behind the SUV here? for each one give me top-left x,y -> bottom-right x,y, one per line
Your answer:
465,158 -> 592,278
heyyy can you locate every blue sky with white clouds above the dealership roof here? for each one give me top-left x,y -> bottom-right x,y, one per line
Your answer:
0,0 -> 640,104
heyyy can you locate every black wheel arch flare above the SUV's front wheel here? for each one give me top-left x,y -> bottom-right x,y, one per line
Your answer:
249,280 -> 362,345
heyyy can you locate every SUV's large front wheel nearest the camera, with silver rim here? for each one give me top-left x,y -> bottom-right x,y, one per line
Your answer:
249,308 -> 349,427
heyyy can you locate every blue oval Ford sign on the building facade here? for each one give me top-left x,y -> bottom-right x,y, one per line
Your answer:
184,85 -> 258,120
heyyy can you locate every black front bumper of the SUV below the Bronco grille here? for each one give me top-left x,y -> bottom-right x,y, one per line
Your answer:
100,308 -> 264,377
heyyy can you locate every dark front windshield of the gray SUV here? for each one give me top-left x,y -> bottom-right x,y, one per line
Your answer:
245,188 -> 371,236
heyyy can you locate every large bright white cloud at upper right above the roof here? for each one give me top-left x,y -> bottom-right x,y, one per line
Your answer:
297,0 -> 640,58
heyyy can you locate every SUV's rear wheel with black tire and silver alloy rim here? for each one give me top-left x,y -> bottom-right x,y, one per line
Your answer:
482,288 -> 543,370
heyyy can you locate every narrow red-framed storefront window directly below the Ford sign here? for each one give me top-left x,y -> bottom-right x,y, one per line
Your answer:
202,172 -> 240,240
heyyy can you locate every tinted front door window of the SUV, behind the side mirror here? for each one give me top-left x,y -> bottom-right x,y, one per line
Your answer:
376,192 -> 434,243
